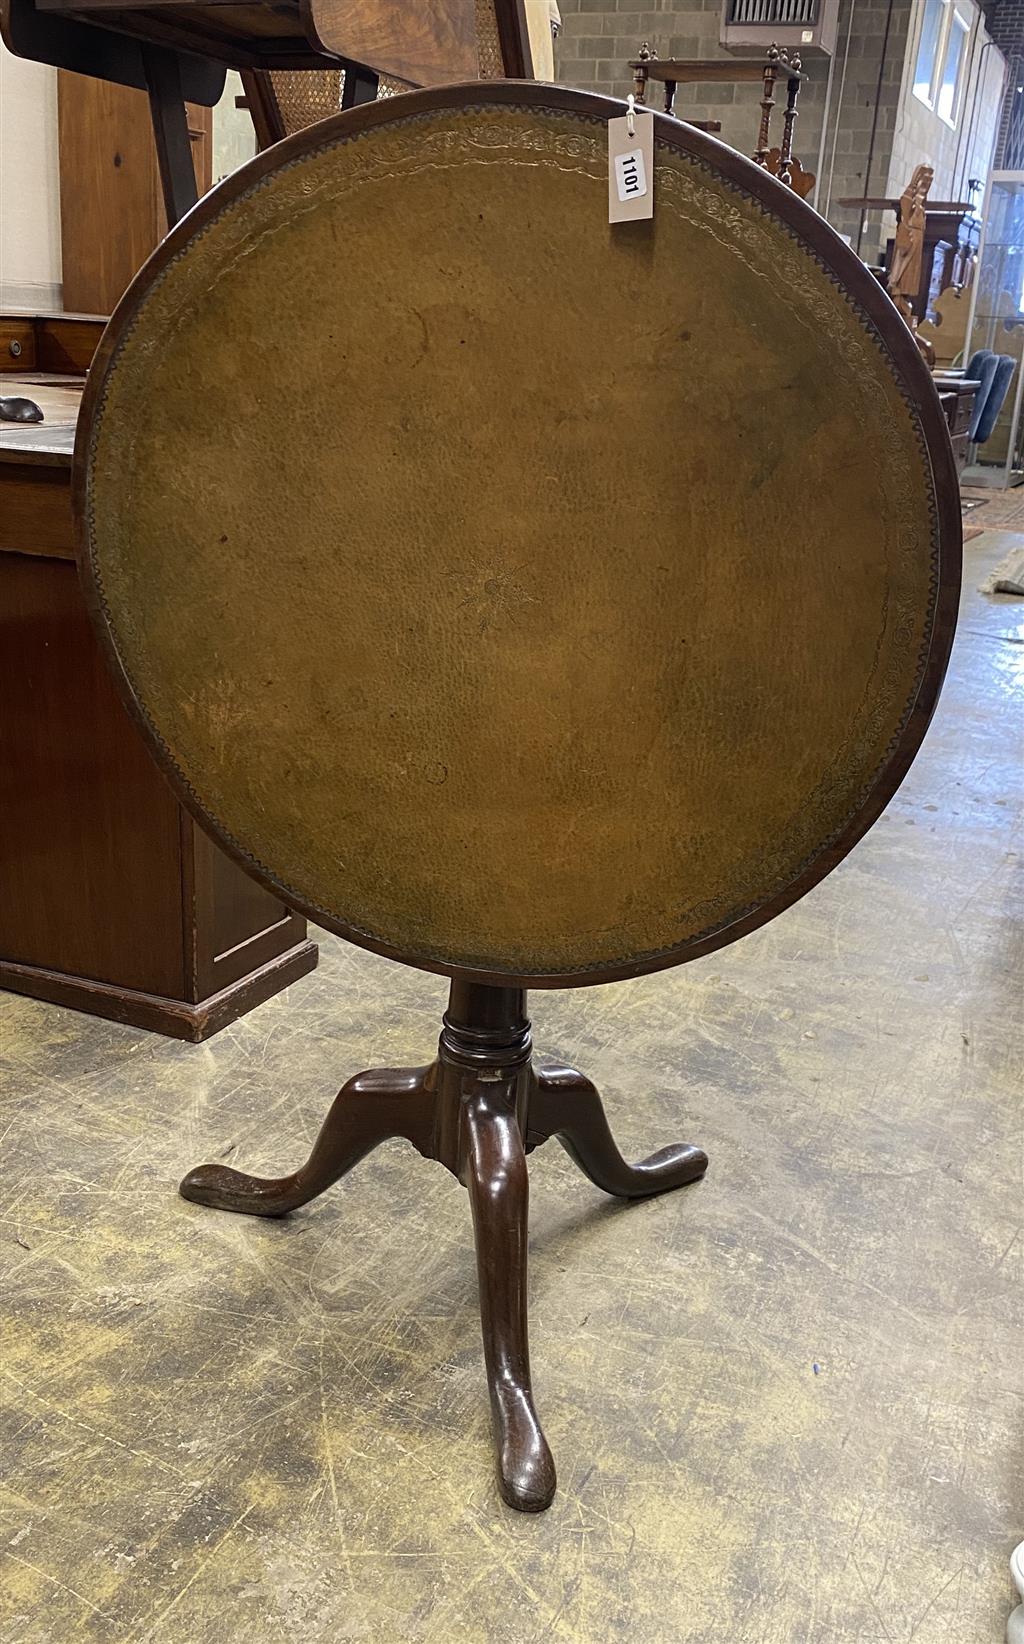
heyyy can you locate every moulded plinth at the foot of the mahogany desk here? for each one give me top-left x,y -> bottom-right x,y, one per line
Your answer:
0,942 -> 319,1044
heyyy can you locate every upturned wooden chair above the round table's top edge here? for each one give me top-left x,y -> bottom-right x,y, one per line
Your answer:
0,0 -> 533,224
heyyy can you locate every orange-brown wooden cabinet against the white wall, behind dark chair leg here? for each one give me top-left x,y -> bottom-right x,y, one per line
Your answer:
58,69 -> 214,314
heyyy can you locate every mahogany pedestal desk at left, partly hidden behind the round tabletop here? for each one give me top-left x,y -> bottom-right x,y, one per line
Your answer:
0,369 -> 317,1041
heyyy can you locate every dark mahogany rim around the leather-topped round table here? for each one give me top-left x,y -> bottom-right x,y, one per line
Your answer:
72,81 -> 962,988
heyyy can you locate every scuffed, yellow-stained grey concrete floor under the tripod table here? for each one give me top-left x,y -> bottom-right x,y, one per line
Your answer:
0,533 -> 1024,1644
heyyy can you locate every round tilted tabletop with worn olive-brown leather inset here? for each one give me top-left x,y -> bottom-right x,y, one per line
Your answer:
76,82 -> 960,986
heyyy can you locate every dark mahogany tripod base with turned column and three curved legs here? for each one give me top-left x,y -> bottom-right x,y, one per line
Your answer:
181,981 -> 707,1512
